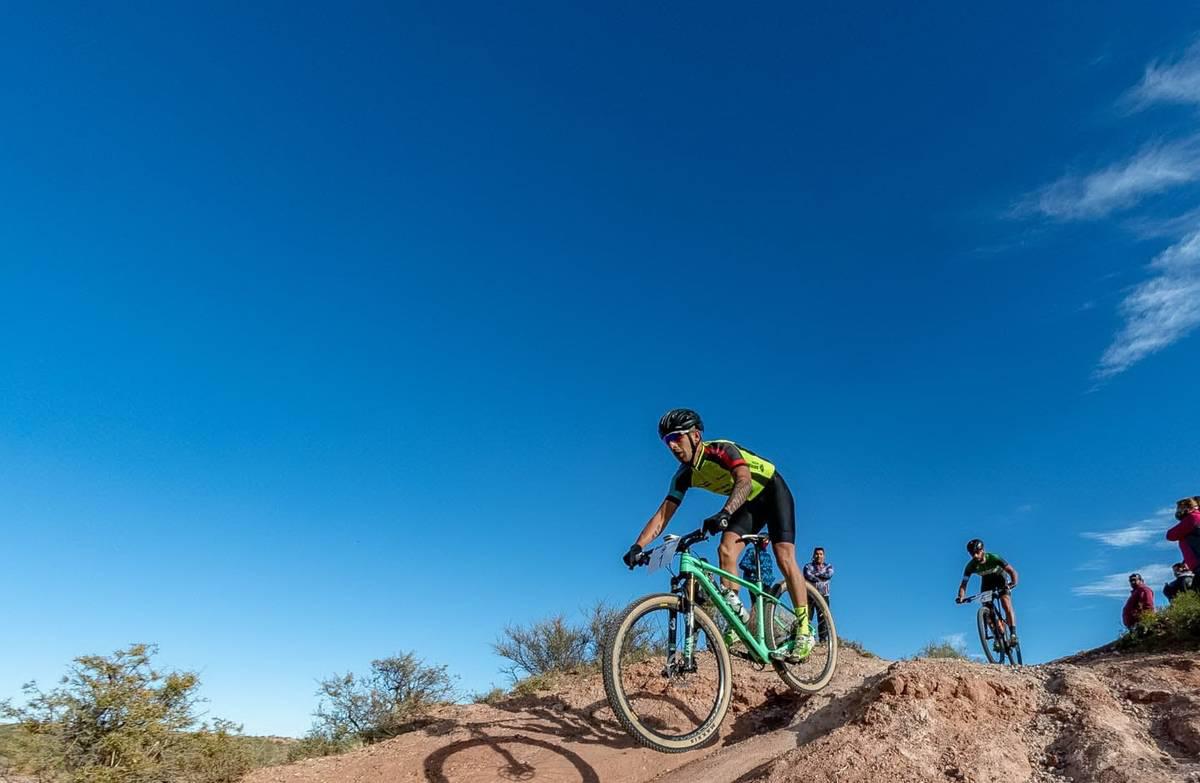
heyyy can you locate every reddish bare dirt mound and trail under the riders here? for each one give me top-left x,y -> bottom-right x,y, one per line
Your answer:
246,650 -> 1200,783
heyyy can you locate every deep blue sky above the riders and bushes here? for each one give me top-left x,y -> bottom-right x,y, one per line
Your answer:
0,4 -> 1200,735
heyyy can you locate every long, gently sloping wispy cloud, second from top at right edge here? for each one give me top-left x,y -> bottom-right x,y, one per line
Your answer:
1015,138 -> 1200,220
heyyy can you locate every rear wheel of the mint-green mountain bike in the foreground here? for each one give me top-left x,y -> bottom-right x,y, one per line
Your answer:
763,582 -> 838,693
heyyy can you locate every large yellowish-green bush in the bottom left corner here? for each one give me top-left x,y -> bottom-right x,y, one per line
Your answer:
0,644 -> 251,783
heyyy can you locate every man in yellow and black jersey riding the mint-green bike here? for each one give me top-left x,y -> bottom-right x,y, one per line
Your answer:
623,408 -> 814,661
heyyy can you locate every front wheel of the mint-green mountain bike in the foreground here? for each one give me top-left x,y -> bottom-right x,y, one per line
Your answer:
602,593 -> 732,753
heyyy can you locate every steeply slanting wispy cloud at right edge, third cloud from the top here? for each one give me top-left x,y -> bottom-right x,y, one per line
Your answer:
1096,228 -> 1200,379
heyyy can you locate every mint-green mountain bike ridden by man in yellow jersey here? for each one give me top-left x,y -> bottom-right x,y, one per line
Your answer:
602,530 -> 838,753
